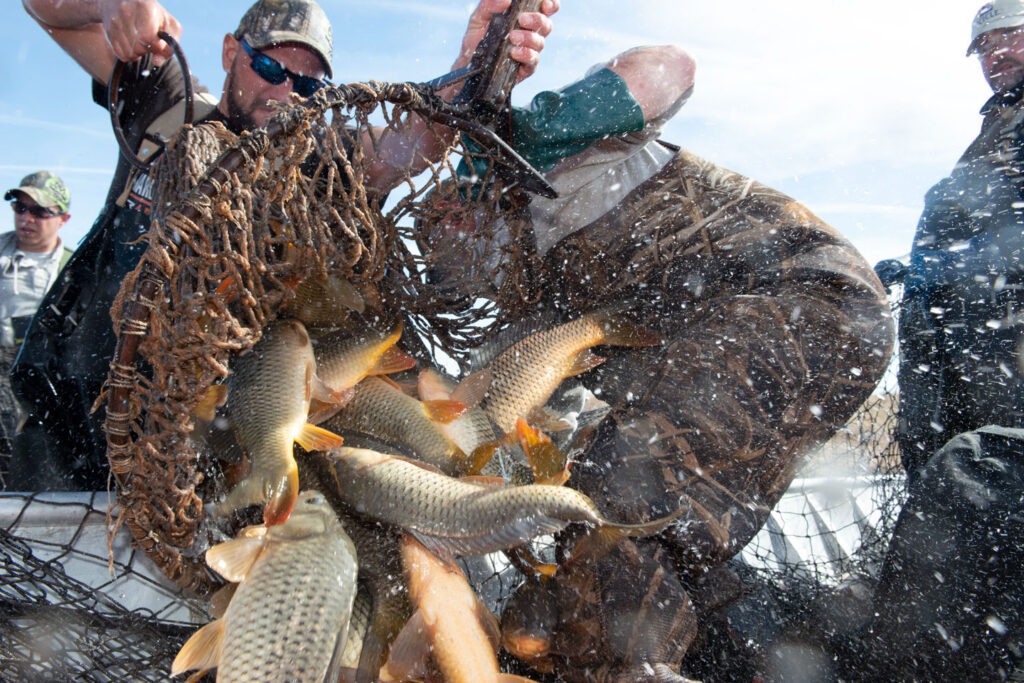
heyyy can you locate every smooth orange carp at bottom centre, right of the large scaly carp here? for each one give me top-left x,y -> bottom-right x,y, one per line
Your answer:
381,536 -> 529,683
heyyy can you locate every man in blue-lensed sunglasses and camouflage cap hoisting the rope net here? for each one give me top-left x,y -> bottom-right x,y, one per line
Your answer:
8,0 -> 559,490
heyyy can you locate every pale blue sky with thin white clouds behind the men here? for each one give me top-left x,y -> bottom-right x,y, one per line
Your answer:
0,0 -> 989,262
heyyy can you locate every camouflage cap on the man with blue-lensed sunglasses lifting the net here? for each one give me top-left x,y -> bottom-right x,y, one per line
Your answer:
234,0 -> 334,78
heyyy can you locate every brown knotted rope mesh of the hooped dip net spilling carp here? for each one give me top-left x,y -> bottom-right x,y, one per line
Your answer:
97,83 -> 544,594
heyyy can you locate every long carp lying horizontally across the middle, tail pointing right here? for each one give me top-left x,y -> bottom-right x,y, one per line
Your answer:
329,446 -> 682,556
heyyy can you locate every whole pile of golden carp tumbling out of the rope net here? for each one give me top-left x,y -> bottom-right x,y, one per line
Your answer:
172,274 -> 679,683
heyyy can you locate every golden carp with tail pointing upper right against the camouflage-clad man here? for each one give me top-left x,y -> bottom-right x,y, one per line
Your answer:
481,311 -> 660,435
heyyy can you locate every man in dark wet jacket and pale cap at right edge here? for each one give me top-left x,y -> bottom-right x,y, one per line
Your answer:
868,0 -> 1024,680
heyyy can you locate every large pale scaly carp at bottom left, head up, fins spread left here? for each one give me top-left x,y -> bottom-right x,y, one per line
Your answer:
171,490 -> 356,683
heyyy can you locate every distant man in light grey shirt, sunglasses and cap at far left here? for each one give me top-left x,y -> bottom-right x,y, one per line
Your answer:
0,171 -> 72,473
